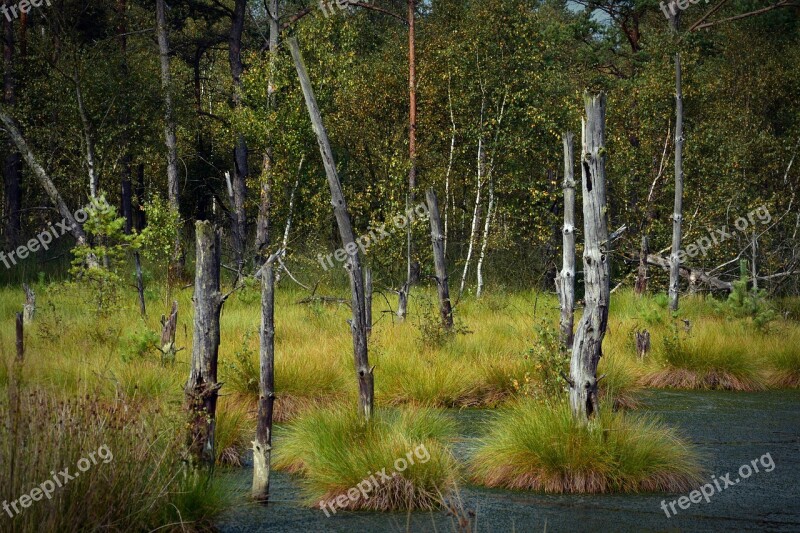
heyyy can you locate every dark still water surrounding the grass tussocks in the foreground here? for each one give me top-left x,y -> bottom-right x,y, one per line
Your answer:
218,391 -> 800,533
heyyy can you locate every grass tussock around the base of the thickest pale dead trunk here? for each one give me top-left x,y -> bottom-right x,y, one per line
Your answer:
470,402 -> 702,493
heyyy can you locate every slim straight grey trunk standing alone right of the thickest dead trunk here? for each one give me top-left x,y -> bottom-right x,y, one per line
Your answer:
669,14 -> 683,311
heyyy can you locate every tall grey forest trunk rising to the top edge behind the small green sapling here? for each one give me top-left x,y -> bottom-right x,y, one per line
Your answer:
156,0 -> 184,270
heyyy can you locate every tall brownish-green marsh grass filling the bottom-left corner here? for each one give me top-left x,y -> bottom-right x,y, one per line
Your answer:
0,389 -> 230,532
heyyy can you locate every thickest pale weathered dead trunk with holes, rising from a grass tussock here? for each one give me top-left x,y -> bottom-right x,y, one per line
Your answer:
569,93 -> 611,421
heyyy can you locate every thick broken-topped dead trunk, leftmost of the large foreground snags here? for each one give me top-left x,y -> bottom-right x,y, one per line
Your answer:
185,220 -> 224,467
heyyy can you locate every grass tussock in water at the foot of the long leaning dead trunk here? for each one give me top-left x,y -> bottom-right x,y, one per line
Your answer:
275,408 -> 458,511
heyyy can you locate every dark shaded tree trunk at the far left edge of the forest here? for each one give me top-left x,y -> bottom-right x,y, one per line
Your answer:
3,7 -> 24,249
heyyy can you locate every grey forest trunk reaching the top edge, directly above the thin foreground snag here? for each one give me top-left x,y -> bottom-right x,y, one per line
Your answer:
255,0 -> 280,266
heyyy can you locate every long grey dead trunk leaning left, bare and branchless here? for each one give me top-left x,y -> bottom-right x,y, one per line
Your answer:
288,37 -> 375,420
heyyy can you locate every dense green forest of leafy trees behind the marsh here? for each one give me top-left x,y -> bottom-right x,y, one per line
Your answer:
0,0 -> 800,294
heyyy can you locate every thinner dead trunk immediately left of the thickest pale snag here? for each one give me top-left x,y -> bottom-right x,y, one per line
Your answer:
556,132 -> 575,349
